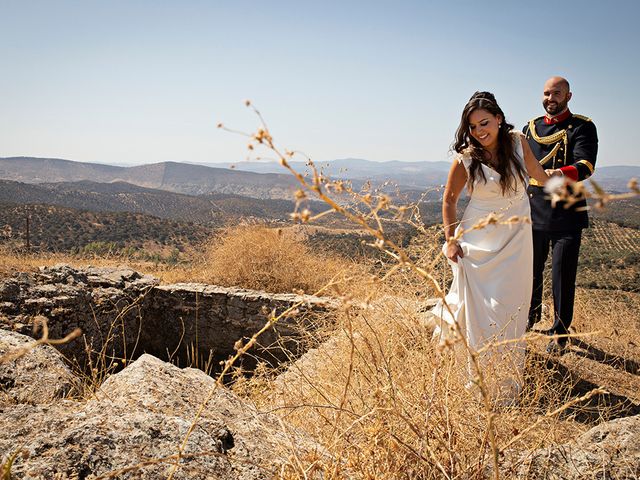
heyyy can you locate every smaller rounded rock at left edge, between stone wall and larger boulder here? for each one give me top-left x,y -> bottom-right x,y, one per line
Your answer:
0,329 -> 78,405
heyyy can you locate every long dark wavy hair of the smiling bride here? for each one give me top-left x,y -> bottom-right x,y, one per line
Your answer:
452,92 -> 526,194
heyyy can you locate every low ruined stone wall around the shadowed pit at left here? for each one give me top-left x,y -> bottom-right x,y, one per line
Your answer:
0,265 -> 337,368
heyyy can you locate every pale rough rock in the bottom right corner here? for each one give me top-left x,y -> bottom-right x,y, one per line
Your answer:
515,415 -> 640,480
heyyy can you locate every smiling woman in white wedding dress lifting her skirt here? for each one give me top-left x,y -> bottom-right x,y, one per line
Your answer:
432,92 -> 548,399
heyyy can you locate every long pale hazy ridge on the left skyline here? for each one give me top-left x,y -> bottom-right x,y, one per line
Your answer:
0,157 -> 296,198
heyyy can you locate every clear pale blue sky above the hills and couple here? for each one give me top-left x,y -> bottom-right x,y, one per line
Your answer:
0,0 -> 640,165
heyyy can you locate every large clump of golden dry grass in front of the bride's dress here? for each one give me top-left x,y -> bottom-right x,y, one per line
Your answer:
235,297 -> 584,479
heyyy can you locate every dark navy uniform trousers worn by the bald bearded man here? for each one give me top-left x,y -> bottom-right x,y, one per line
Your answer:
529,229 -> 582,335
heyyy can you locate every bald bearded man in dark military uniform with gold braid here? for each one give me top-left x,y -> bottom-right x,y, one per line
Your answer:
522,77 -> 598,354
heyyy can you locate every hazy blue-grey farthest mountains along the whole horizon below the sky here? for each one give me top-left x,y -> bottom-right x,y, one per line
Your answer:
0,157 -> 640,195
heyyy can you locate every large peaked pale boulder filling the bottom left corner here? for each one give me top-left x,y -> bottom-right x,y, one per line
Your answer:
0,355 -> 320,480
